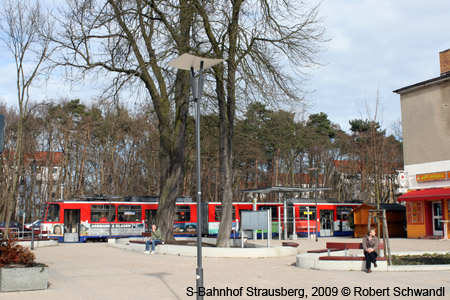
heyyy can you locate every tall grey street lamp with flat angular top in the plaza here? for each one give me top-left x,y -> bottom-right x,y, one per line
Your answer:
169,53 -> 223,299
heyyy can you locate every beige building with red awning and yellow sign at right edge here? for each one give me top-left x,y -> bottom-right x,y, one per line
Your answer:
394,49 -> 450,238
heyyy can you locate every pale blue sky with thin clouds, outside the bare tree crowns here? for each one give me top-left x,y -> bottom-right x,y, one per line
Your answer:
0,0 -> 450,131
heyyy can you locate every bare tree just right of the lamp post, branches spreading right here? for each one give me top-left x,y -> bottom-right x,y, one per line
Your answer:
193,0 -> 324,246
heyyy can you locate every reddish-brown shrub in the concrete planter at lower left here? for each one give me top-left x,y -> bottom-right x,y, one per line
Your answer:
0,239 -> 36,268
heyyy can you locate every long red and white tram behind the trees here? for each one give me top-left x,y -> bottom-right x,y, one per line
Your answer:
41,196 -> 360,242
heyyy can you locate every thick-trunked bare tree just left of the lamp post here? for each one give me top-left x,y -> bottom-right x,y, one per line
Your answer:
51,0 -> 192,239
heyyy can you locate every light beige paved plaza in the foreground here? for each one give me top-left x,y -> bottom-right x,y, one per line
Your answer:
0,238 -> 450,300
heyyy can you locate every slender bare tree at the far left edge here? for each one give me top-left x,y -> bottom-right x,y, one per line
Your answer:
0,0 -> 52,232
